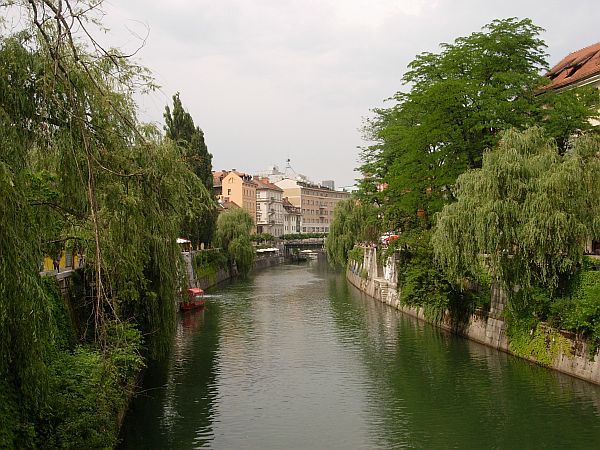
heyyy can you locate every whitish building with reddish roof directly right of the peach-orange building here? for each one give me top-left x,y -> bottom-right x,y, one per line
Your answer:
254,177 -> 284,237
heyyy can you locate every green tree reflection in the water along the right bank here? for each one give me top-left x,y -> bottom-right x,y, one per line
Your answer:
328,278 -> 600,448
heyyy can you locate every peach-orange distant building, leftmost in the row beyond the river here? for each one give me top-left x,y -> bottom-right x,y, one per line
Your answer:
213,169 -> 256,231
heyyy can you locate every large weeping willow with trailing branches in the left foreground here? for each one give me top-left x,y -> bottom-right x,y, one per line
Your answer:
0,0 -> 210,438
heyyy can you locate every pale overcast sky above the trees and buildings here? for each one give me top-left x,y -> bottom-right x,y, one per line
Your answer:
99,0 -> 600,187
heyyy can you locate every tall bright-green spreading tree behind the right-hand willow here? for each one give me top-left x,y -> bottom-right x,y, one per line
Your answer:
360,18 -> 598,227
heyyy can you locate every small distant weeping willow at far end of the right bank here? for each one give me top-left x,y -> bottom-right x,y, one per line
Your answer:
325,199 -> 379,266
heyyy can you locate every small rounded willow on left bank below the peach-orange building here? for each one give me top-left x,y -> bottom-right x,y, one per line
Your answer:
215,208 -> 256,277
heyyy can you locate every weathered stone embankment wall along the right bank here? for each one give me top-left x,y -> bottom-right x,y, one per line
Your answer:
346,247 -> 600,384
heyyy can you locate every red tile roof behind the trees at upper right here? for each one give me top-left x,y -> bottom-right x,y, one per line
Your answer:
543,42 -> 600,90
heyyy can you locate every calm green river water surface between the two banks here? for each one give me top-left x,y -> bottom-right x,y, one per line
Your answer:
121,263 -> 600,449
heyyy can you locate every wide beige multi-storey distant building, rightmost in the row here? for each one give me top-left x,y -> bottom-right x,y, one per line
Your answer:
275,178 -> 350,233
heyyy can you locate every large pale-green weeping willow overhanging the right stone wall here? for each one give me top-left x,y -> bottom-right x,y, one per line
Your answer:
432,128 -> 600,297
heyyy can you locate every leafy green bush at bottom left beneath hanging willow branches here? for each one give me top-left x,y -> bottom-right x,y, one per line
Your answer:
38,323 -> 143,448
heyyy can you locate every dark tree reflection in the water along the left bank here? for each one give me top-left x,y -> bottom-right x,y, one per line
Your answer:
122,302 -> 220,448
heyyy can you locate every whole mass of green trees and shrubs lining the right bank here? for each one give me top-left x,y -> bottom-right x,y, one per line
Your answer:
327,18 -> 600,348
